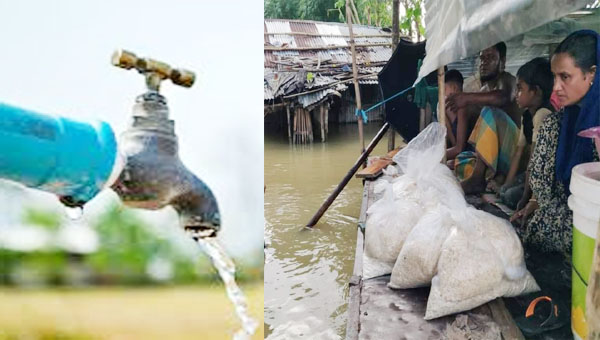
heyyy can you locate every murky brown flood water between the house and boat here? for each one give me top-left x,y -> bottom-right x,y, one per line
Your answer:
265,122 -> 392,340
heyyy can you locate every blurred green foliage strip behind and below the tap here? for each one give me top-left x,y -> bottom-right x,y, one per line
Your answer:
0,207 -> 262,286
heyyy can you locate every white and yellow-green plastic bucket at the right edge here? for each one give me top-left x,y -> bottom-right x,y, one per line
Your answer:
569,162 -> 600,340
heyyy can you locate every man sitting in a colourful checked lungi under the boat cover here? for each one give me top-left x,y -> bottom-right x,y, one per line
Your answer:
446,42 -> 521,194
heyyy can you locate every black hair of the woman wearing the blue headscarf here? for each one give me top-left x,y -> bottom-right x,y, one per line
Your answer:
554,34 -> 597,72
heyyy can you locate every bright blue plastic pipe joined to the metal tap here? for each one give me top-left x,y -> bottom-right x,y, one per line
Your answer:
0,103 -> 117,202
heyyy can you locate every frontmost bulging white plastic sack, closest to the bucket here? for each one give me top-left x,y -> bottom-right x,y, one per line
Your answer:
425,208 -> 540,320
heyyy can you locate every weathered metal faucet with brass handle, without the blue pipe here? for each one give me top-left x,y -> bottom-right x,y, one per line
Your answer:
111,50 -> 221,239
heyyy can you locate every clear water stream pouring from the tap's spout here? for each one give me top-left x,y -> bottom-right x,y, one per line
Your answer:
198,238 -> 258,340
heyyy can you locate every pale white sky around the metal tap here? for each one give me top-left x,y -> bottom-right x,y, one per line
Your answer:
0,0 -> 264,256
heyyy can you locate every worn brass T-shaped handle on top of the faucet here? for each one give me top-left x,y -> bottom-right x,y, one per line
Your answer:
111,50 -> 196,92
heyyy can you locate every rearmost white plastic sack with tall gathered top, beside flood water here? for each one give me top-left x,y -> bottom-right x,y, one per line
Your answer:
363,123 -> 467,278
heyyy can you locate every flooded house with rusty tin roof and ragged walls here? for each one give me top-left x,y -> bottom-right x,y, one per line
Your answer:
264,19 -> 393,143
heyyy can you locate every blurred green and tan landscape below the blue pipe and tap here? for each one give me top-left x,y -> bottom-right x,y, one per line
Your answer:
0,181 -> 264,340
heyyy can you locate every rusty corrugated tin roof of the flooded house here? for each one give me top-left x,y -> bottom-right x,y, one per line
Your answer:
264,19 -> 393,103
